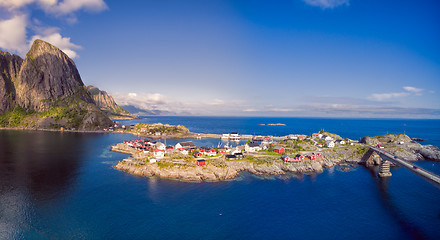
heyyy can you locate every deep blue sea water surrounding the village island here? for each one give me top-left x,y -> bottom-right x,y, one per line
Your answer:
0,117 -> 440,239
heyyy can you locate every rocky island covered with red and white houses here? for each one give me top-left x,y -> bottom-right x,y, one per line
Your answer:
111,131 -> 440,181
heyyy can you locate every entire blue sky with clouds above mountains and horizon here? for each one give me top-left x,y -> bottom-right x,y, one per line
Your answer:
0,0 -> 440,118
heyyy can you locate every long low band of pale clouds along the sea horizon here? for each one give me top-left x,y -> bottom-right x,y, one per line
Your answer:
113,89 -> 440,118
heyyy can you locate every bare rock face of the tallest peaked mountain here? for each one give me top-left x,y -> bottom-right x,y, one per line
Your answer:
15,40 -> 93,112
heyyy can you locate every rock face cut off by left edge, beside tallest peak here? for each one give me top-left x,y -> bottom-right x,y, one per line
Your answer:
0,51 -> 23,114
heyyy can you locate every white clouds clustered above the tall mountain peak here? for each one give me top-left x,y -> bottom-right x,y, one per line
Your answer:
0,0 -> 107,58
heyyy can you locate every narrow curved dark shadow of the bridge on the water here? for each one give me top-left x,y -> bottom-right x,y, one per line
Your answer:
365,166 -> 429,239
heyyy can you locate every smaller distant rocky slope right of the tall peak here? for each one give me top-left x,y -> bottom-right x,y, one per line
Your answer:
87,86 -> 136,118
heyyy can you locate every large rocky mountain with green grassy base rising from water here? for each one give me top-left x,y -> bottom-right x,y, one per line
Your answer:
0,40 -> 112,129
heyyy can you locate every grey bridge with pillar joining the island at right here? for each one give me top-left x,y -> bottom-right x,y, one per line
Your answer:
369,146 -> 440,188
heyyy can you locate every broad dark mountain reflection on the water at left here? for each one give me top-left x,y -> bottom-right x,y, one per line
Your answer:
0,131 -> 86,201
